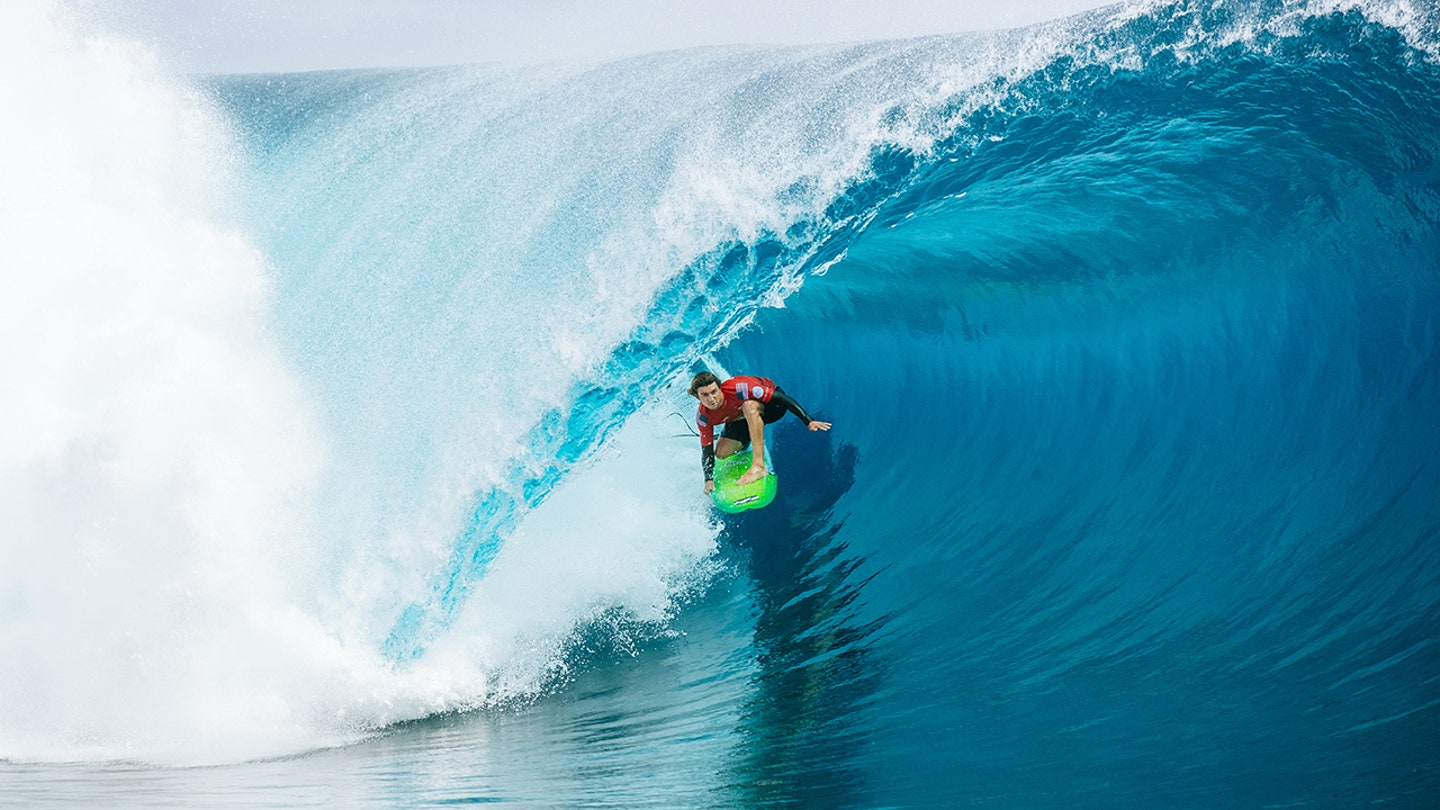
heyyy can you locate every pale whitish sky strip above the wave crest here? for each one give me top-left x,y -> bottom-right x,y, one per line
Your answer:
66,0 -> 1115,74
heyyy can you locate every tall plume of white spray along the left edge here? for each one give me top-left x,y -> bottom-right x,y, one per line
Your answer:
0,3 -> 341,758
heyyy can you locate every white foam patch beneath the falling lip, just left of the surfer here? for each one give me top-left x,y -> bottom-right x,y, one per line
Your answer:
408,406 -> 717,708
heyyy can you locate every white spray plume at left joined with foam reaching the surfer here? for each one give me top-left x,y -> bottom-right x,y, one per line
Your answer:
0,3 -> 713,762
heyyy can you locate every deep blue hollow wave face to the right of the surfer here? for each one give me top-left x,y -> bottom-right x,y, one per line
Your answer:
727,9 -> 1440,807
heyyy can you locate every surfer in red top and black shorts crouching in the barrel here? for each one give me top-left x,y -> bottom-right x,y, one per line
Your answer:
690,372 -> 829,493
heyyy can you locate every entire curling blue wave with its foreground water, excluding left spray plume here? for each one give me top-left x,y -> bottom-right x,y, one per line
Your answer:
8,3 -> 1440,809
